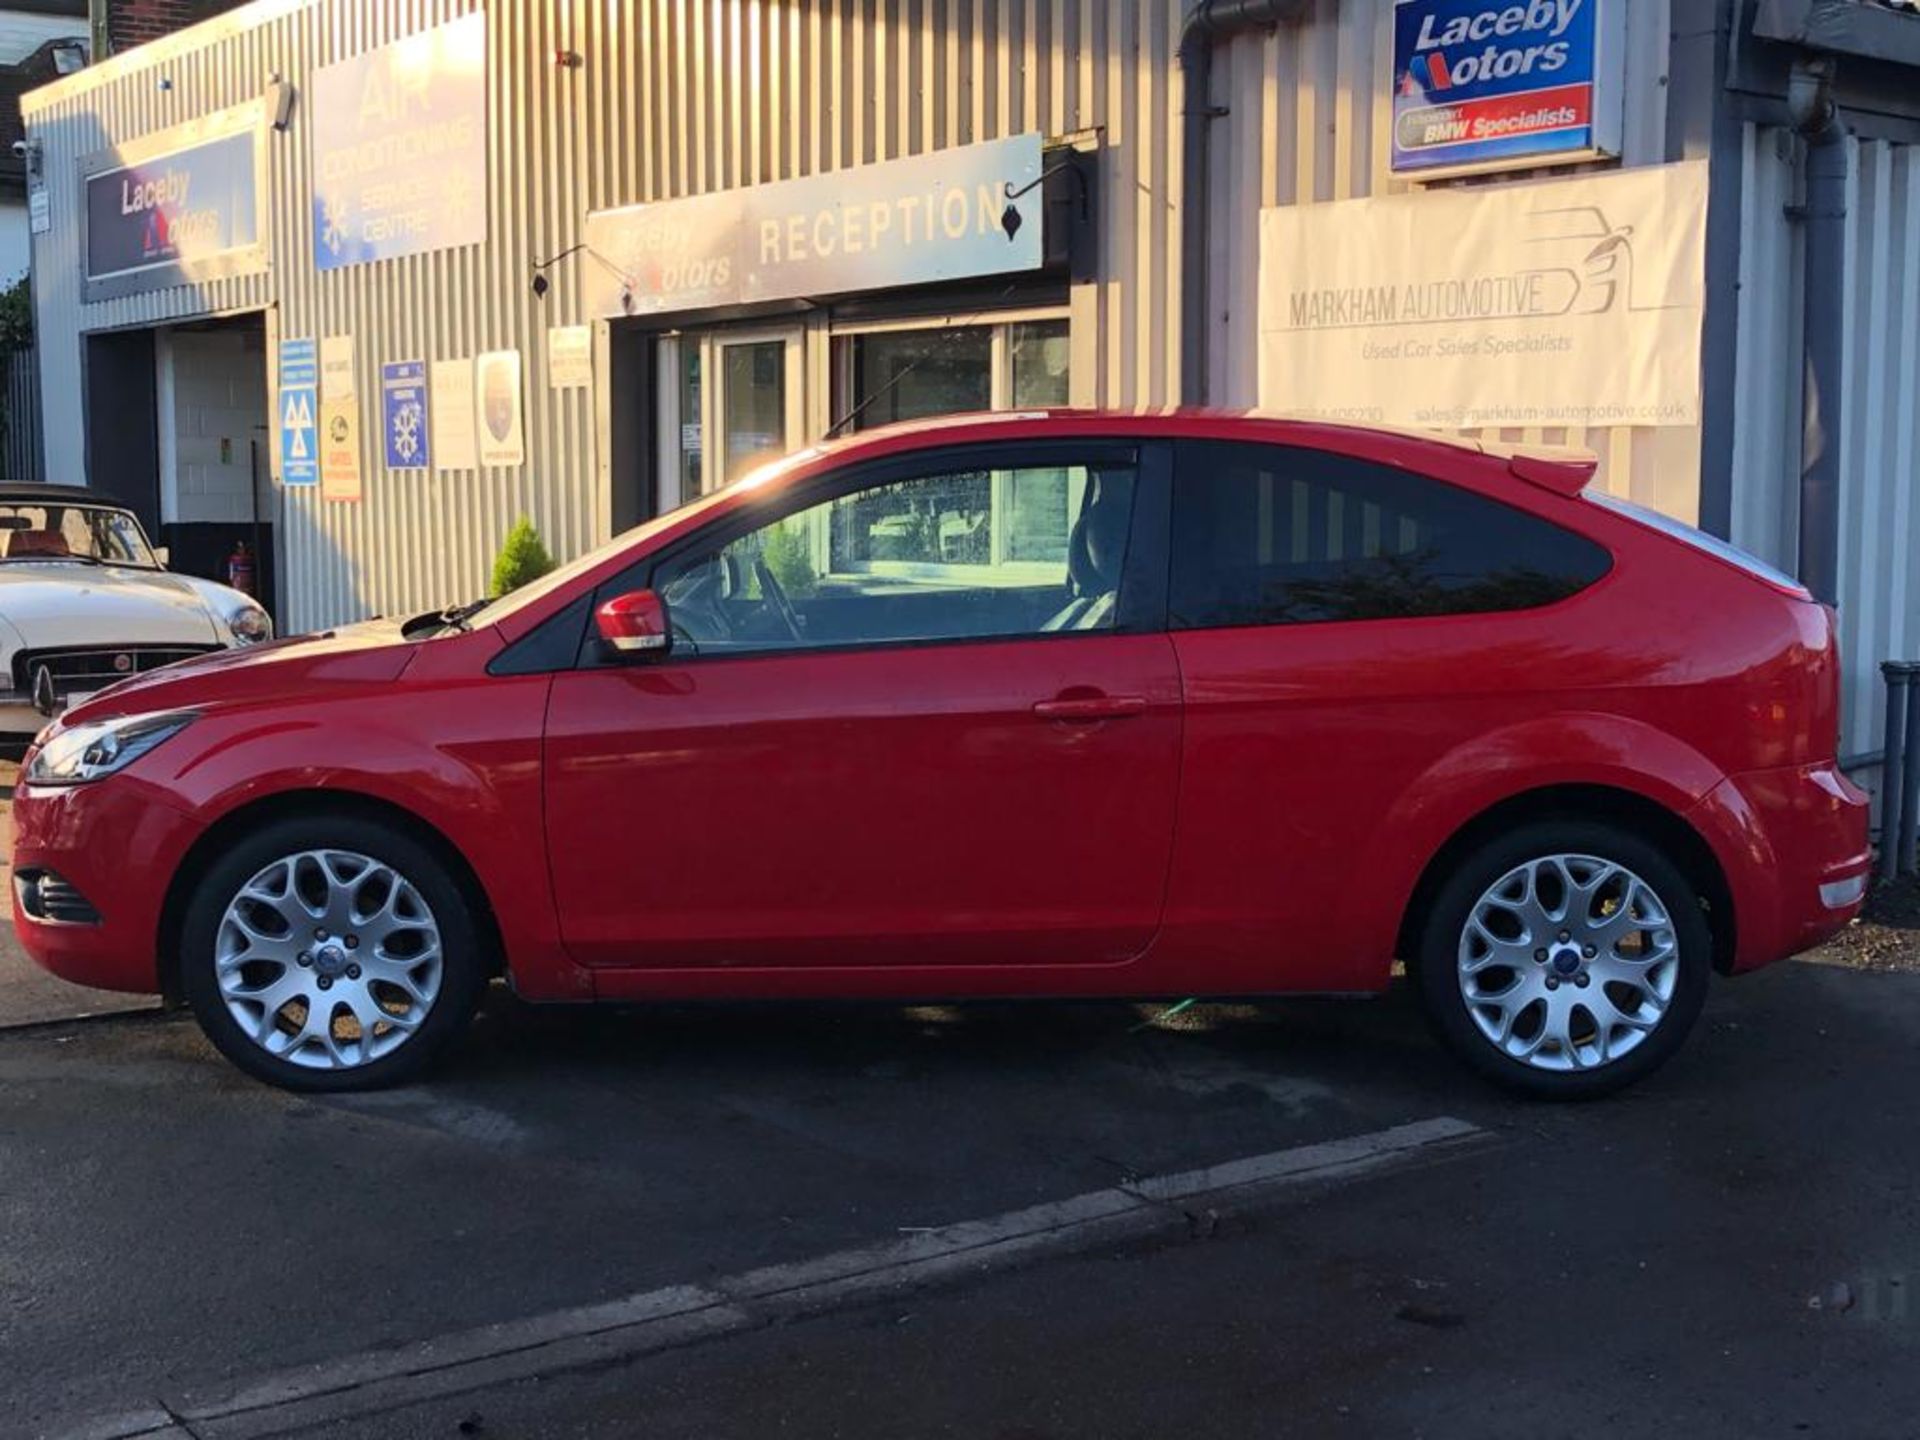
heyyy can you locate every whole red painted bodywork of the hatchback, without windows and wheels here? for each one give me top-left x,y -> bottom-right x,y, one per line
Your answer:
13,413 -> 1868,1000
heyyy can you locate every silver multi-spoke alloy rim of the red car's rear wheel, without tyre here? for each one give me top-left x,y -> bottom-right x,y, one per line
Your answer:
1459,854 -> 1680,1071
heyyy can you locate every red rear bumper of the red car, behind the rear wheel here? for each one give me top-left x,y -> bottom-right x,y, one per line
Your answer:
1692,762 -> 1874,973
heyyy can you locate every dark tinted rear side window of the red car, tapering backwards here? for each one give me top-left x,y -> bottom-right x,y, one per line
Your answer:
1167,442 -> 1613,630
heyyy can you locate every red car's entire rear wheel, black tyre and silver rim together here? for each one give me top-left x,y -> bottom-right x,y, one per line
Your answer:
1411,820 -> 1713,1100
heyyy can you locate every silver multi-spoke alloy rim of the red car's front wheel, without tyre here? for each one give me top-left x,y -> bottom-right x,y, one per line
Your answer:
213,849 -> 444,1069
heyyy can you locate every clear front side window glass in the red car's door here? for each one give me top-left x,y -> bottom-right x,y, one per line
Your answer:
653,463 -> 1135,655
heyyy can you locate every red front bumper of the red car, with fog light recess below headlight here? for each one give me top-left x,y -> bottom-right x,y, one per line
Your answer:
12,774 -> 200,995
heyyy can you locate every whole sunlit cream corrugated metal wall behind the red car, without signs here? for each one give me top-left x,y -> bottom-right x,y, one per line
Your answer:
29,0 -> 1697,628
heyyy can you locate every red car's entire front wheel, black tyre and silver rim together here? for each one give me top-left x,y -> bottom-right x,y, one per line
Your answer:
180,816 -> 488,1092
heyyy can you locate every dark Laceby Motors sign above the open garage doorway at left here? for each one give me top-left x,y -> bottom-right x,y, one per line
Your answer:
81,104 -> 267,300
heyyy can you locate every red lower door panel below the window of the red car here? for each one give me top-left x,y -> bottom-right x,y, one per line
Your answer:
547,636 -> 1181,970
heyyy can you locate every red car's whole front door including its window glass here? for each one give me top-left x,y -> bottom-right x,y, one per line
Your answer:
545,444 -> 1181,968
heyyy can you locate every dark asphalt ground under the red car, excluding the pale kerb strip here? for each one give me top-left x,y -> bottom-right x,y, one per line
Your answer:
0,964 -> 1920,1440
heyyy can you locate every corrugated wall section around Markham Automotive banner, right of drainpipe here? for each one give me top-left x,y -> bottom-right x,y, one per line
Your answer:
1210,0 -> 1699,522
